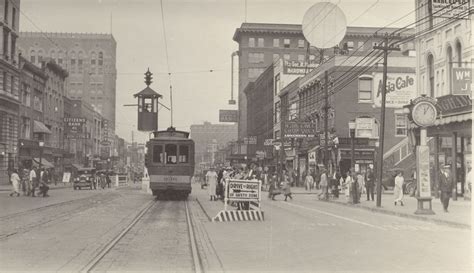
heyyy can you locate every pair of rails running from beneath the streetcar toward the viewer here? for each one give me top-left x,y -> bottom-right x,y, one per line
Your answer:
80,199 -> 204,273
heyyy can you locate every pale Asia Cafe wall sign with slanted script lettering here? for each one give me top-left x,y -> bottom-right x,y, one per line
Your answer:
372,73 -> 416,108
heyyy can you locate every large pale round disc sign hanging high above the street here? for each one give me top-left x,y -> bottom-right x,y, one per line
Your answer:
302,2 -> 347,49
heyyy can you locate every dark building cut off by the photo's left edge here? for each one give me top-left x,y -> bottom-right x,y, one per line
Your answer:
0,0 -> 20,184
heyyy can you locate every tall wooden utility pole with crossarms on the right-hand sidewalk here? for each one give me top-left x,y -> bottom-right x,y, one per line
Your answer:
374,34 -> 400,207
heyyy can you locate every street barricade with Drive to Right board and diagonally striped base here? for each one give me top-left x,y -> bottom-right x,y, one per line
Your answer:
212,179 -> 264,222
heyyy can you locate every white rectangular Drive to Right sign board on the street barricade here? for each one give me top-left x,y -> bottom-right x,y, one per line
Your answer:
226,179 -> 262,202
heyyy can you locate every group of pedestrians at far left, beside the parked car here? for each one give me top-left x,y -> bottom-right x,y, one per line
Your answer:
10,167 -> 51,197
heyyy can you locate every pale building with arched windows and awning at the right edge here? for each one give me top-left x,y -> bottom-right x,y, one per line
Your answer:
415,0 -> 474,196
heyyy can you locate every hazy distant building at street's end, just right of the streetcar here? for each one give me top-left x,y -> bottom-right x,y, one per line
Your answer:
191,122 -> 237,168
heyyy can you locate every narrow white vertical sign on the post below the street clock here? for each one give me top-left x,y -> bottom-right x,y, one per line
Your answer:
416,145 -> 431,197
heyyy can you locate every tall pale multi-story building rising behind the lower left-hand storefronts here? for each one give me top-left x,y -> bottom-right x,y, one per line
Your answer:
18,32 -> 117,132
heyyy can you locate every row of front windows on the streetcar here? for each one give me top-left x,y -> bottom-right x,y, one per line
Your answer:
153,144 -> 189,164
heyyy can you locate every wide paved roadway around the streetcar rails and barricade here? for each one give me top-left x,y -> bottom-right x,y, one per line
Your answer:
0,186 -> 472,272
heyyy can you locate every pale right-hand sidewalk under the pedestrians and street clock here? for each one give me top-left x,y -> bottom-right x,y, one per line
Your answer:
291,187 -> 472,229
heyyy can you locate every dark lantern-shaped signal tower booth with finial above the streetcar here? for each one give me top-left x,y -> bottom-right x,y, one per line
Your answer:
133,69 -> 163,132
